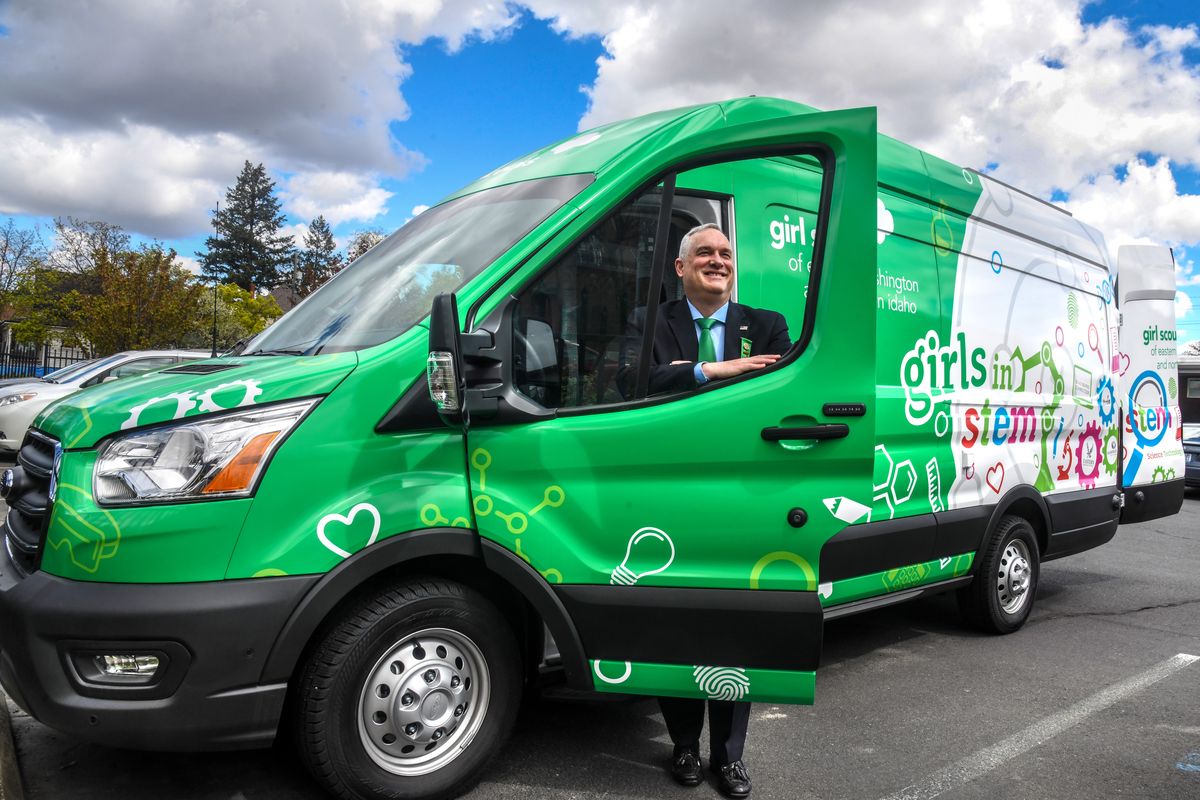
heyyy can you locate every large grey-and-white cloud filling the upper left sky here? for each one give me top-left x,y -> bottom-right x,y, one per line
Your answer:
0,0 -> 516,237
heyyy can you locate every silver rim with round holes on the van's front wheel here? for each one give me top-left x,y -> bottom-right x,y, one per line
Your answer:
359,627 -> 491,775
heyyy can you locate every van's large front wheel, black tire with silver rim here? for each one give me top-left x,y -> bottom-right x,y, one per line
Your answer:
295,578 -> 521,800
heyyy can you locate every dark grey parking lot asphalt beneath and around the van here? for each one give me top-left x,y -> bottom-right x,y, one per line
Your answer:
0,491 -> 1200,800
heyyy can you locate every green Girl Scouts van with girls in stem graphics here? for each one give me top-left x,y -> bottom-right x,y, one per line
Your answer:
0,97 -> 1183,798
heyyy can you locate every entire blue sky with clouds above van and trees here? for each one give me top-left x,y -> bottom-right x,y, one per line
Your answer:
0,0 -> 1200,341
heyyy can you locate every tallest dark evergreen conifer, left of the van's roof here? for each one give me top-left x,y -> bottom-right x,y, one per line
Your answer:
196,161 -> 295,293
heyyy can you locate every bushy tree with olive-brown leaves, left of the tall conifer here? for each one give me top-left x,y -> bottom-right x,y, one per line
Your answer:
71,246 -> 204,353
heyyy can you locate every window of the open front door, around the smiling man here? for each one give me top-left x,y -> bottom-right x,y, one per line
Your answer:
514,156 -> 823,409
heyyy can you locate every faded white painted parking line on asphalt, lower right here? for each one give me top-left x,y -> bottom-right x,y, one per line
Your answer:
883,652 -> 1200,800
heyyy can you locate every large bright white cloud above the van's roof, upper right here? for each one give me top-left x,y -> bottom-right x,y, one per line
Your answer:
529,0 -> 1200,256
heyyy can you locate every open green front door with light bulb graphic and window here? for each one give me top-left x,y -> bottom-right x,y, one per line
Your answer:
436,109 -> 877,703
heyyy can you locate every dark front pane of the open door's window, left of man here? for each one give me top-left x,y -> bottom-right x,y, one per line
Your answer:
512,188 -> 721,408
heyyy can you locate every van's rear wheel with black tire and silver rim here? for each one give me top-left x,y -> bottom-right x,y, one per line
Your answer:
959,516 -> 1040,633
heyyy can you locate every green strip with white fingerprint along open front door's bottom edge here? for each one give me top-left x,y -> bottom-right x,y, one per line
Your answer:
592,658 -> 816,705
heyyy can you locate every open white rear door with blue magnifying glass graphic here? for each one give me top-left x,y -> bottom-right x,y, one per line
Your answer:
1114,245 -> 1184,523
